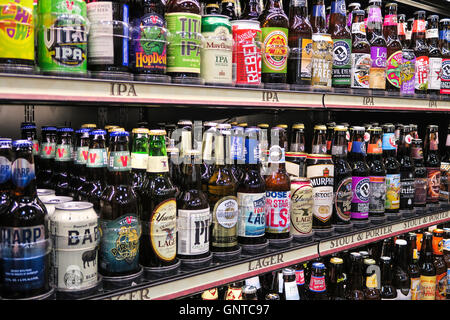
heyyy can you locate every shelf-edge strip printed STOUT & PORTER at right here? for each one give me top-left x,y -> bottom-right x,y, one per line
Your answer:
319,211 -> 450,256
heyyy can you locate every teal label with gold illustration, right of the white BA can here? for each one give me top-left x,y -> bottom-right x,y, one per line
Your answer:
99,214 -> 141,273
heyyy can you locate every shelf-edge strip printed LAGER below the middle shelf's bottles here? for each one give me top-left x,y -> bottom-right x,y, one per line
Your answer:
100,243 -> 319,300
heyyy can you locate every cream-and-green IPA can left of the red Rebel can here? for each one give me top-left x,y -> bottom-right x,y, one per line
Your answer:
200,15 -> 233,85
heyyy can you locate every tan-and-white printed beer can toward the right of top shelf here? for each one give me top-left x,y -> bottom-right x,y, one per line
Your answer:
311,33 -> 333,90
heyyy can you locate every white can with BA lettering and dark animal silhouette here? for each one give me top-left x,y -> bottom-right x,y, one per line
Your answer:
50,201 -> 99,292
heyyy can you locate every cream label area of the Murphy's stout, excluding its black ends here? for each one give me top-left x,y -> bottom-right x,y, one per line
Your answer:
306,164 -> 334,224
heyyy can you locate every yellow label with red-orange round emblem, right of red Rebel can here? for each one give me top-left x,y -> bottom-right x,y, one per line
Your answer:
261,27 -> 288,73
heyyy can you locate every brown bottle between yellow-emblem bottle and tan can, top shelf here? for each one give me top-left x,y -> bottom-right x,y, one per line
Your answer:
287,0 -> 312,88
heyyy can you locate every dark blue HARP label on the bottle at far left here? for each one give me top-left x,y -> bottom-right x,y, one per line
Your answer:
0,225 -> 50,292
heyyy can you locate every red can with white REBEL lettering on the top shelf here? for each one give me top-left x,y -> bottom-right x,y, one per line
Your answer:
231,20 -> 261,86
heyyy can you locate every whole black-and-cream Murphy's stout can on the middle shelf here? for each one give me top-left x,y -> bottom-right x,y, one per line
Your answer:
306,154 -> 334,229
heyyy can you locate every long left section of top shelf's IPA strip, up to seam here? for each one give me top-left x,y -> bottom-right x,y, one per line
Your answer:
0,75 -> 323,108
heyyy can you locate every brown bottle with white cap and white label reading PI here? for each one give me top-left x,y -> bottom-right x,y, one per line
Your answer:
177,150 -> 211,259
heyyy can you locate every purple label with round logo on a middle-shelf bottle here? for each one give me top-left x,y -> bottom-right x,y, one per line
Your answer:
350,176 -> 370,219
